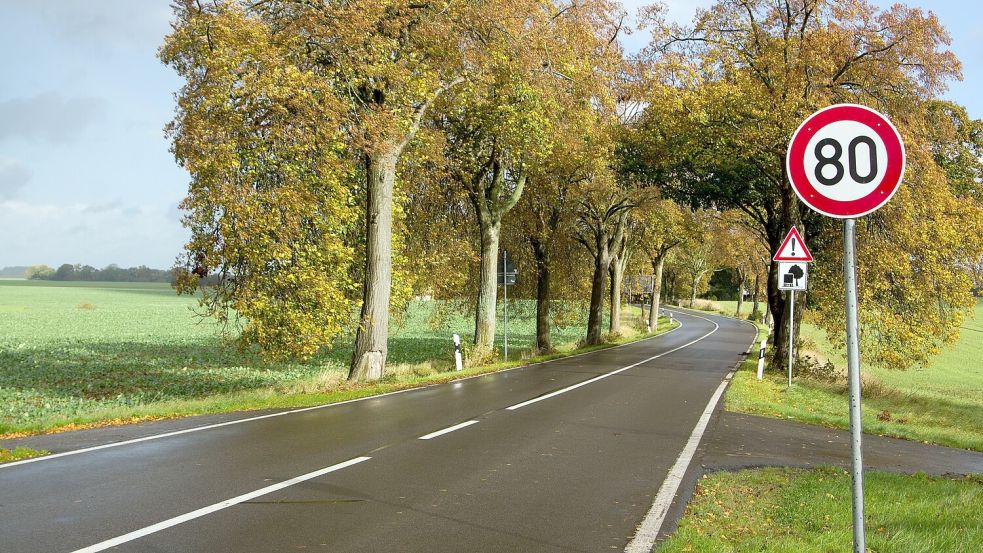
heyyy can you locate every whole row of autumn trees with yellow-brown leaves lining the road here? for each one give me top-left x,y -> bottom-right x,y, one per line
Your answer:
160,0 -> 983,380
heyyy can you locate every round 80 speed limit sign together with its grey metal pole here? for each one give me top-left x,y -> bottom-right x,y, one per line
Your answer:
785,104 -> 905,553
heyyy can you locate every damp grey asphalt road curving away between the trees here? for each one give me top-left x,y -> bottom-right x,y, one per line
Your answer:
0,313 -> 755,553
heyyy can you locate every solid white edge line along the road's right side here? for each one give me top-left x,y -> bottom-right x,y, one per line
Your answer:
625,315 -> 757,553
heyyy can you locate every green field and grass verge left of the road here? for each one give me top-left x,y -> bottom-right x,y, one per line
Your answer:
0,280 -> 672,438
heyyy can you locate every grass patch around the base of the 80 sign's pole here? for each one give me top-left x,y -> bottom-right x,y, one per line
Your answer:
658,467 -> 983,553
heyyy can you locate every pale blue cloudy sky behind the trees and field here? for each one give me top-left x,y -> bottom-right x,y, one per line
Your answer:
0,0 -> 983,268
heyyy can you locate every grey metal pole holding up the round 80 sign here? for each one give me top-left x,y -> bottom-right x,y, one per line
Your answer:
843,219 -> 866,553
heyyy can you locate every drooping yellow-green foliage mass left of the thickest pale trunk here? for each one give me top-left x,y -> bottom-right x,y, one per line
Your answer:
160,1 -> 357,358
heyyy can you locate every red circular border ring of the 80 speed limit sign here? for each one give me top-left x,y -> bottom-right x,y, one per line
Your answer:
785,104 -> 905,219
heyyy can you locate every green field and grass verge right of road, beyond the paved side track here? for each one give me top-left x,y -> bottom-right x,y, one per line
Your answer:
717,302 -> 983,451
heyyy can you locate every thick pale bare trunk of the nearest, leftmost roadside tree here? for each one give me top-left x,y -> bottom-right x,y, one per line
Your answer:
348,148 -> 399,381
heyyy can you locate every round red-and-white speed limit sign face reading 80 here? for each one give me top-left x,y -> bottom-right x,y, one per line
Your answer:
785,104 -> 905,219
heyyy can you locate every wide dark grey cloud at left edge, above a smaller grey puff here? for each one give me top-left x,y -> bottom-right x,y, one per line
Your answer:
0,92 -> 106,144
